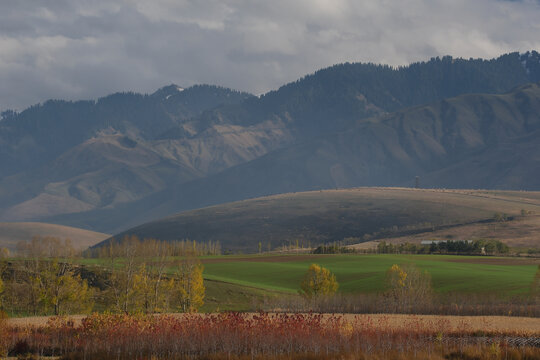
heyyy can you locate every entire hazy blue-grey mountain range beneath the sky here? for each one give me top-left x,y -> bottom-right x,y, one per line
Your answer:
0,51 -> 540,233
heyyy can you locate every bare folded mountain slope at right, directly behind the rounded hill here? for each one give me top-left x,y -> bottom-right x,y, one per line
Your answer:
75,84 -> 540,225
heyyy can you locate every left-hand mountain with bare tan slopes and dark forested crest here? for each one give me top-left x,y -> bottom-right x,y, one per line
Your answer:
0,85 -> 290,221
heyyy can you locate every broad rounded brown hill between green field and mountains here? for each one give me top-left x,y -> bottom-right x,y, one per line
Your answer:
97,188 -> 540,252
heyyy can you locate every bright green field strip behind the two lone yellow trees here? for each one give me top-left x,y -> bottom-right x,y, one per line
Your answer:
199,254 -> 538,297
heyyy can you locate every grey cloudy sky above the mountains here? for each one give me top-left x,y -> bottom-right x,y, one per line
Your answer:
0,0 -> 540,110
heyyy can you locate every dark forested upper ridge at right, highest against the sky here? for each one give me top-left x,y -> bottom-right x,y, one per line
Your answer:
198,51 -> 540,137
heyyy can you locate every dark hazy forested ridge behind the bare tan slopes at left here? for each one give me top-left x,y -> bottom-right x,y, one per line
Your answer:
0,85 -> 252,177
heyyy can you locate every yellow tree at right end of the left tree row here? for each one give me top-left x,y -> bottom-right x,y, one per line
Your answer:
174,257 -> 206,312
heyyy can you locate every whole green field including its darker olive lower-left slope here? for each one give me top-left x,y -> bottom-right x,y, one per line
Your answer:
80,254 -> 540,312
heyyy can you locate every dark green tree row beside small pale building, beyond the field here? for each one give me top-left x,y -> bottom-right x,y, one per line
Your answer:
377,240 -> 510,255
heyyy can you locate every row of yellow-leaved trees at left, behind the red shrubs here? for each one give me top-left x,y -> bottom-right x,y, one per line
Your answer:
0,236 -> 205,315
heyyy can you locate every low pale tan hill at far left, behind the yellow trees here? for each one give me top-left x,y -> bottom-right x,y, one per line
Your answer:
0,223 -> 109,252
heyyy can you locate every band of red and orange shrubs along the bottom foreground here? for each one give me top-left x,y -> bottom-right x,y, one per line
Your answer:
0,313 -> 540,359
